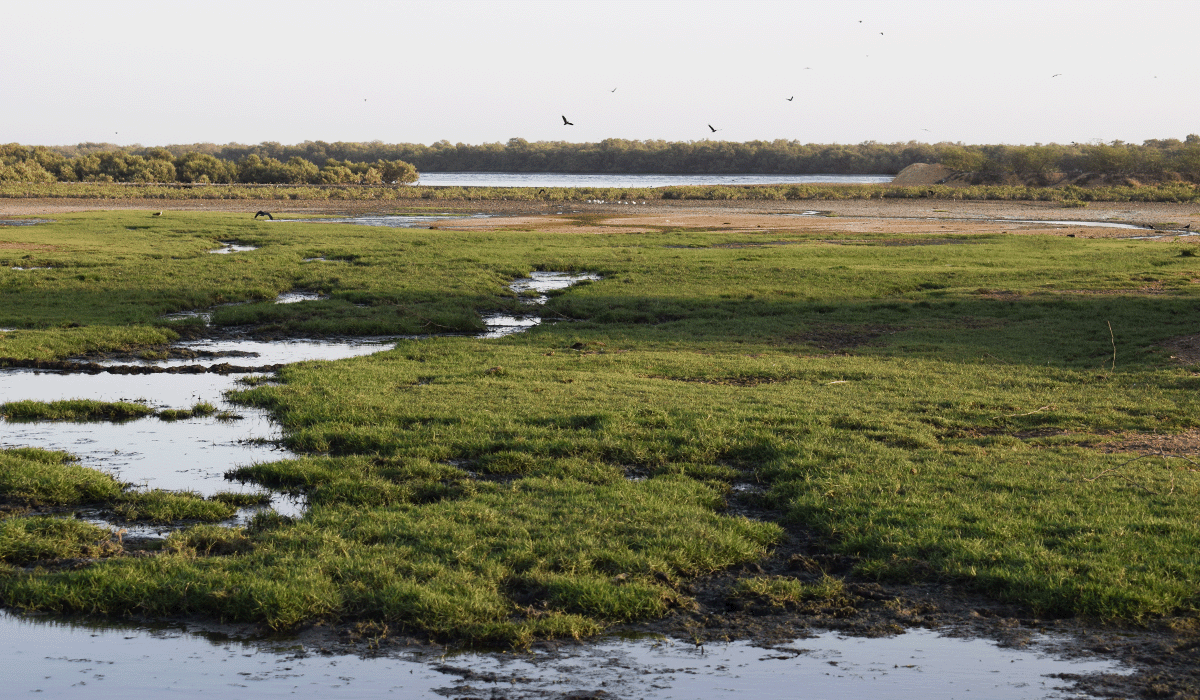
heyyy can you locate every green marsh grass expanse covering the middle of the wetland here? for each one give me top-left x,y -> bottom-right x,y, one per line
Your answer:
0,211 -> 1200,645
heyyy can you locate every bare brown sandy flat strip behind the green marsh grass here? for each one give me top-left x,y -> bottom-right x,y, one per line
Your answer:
0,198 -> 1200,243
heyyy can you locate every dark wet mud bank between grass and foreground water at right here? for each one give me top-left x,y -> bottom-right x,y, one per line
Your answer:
617,501 -> 1200,700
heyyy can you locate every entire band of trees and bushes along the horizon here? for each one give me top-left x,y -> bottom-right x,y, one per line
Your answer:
0,134 -> 1200,185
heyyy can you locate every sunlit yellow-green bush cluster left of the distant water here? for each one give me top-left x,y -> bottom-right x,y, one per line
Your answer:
0,143 -> 418,185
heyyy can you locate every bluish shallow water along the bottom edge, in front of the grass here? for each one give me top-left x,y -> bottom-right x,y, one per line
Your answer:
0,612 -> 1128,700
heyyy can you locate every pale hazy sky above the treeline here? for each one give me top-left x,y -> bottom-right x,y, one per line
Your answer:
0,0 -> 1200,145
